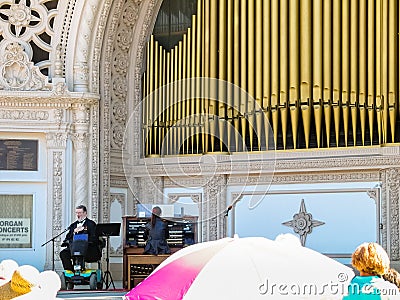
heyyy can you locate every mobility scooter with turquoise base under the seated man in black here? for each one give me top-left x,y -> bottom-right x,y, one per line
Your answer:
60,234 -> 105,290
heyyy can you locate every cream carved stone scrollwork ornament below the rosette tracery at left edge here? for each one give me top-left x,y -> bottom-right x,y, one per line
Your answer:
0,41 -> 50,91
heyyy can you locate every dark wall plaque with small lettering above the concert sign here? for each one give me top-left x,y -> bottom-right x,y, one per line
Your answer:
0,140 -> 38,171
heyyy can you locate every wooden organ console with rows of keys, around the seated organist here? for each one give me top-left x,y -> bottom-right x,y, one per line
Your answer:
122,216 -> 197,289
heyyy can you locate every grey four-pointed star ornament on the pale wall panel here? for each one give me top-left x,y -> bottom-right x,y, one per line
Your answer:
282,199 -> 325,246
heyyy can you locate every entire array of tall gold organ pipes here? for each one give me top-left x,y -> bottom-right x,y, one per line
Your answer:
142,0 -> 400,156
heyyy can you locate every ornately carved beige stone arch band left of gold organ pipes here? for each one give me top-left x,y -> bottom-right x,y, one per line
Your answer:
98,0 -> 162,217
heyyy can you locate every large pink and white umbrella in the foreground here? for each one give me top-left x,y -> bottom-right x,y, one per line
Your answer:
125,234 -> 354,300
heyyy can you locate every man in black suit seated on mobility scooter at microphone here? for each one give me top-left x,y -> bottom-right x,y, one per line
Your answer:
60,205 -> 104,289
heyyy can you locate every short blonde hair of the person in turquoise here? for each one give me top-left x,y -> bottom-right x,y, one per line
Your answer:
351,243 -> 390,275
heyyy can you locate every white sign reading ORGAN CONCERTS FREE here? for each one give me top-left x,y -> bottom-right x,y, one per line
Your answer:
0,218 -> 31,248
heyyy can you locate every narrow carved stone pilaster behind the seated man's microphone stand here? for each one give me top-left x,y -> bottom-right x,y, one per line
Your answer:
45,133 -> 68,269
